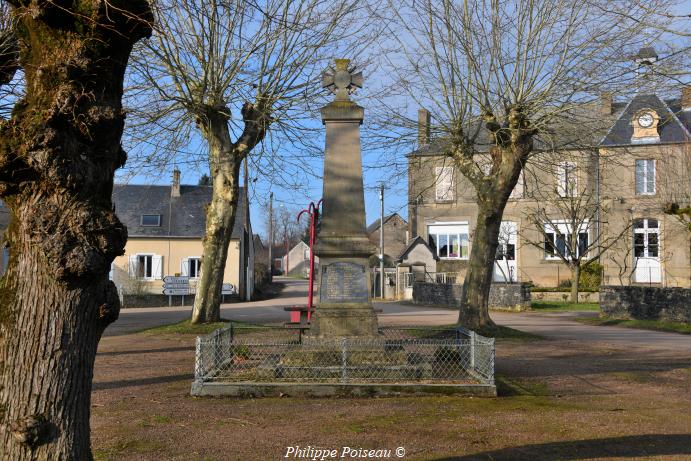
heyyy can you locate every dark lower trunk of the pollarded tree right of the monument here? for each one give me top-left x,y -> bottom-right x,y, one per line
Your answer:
458,202 -> 504,328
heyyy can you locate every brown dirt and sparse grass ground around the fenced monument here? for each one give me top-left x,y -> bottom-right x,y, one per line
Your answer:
92,326 -> 691,461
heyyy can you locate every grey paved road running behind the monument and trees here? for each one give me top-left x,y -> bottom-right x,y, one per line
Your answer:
105,277 -> 691,354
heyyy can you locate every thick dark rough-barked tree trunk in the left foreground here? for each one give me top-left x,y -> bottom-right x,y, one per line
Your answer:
0,0 -> 150,461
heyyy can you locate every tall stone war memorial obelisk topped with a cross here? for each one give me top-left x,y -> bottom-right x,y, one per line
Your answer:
309,59 -> 378,340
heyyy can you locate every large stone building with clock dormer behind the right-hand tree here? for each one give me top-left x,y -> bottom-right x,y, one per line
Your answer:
407,86 -> 691,287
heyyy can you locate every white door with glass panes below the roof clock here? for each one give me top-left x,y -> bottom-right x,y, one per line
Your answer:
633,219 -> 662,283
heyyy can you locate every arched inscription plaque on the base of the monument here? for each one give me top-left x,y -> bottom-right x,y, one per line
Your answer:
319,261 -> 369,303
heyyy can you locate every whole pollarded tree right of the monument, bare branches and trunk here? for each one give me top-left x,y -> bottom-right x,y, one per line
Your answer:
391,0 -> 676,327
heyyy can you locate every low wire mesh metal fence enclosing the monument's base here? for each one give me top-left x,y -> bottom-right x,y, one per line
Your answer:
195,324 -> 495,385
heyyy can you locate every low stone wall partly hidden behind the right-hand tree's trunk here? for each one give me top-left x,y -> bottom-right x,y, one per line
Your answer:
413,282 -> 530,310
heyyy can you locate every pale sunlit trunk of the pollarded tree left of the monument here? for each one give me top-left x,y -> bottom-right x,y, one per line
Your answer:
192,110 -> 242,323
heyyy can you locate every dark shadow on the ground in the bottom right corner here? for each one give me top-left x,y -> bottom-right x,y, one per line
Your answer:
436,434 -> 691,461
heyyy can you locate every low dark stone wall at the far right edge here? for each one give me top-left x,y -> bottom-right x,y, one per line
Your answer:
600,286 -> 691,323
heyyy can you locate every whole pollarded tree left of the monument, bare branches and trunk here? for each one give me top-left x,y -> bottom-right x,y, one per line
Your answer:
133,0 -> 374,323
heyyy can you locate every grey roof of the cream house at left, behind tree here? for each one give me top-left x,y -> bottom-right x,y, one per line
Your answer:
113,184 -> 245,239
